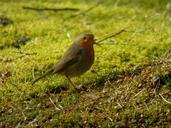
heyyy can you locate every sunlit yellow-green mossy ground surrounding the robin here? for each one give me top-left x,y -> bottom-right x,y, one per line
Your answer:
0,0 -> 171,127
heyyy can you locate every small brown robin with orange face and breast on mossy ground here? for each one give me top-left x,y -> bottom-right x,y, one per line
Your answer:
31,33 -> 95,88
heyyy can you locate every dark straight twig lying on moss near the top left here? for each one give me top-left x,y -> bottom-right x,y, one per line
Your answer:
23,6 -> 80,12
